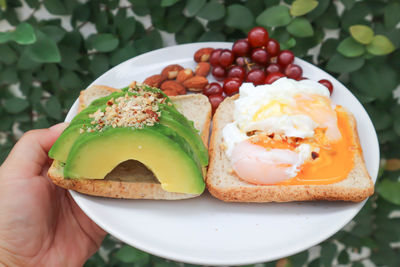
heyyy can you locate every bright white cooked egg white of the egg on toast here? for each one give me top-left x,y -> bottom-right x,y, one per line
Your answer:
222,78 -> 329,181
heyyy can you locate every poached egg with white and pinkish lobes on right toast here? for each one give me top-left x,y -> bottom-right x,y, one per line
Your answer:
223,78 -> 354,185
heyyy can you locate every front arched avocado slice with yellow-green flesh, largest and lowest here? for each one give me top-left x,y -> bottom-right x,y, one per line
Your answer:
64,124 -> 205,194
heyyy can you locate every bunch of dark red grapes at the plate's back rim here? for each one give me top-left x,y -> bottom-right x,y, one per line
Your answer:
203,27 -> 333,114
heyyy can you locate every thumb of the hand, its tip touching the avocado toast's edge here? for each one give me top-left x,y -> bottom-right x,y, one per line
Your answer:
1,123 -> 67,177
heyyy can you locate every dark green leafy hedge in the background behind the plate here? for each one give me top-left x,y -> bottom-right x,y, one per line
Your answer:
0,0 -> 400,266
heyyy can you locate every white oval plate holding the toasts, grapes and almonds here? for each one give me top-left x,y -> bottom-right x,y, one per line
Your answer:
66,43 -> 379,265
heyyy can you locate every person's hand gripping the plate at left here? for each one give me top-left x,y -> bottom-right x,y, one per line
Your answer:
0,124 -> 105,266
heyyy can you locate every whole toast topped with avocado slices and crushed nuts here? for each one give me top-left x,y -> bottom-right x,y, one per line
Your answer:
48,83 -> 211,199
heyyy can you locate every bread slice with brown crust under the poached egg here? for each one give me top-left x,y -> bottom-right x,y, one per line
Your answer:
206,96 -> 374,202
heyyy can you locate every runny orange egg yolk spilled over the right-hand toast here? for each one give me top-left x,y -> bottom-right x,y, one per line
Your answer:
278,107 -> 358,185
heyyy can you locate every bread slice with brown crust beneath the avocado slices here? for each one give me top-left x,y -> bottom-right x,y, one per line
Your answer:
48,85 -> 211,200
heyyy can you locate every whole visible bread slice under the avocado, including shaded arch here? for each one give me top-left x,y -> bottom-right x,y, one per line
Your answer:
48,85 -> 211,200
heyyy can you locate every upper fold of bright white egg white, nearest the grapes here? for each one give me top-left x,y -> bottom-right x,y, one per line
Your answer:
223,78 -> 329,157
